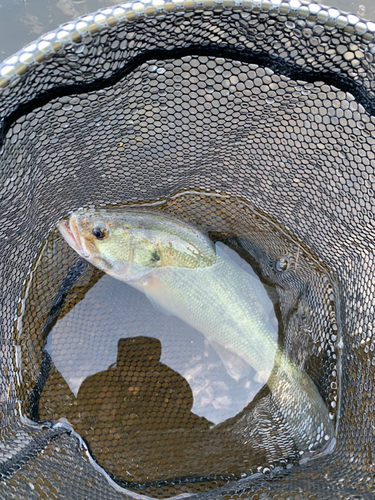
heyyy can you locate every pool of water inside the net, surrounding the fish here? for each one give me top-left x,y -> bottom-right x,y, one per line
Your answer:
16,190 -> 340,498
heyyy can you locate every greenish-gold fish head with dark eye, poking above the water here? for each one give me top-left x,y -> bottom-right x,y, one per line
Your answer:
59,209 -> 216,281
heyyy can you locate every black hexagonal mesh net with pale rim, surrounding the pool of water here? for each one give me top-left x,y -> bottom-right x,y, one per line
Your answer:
0,2 -> 375,499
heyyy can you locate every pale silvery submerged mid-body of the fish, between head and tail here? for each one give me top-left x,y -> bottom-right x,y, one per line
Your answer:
144,249 -> 277,374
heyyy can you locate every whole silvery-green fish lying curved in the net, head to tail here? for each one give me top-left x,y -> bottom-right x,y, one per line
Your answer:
59,208 -> 333,447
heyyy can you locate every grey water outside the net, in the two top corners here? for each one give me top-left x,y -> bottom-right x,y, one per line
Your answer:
0,0 -> 375,61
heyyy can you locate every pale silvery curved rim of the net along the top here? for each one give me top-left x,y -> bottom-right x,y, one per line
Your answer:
0,0 -> 375,91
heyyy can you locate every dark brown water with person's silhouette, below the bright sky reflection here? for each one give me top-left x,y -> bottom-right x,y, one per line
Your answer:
39,336 -> 295,498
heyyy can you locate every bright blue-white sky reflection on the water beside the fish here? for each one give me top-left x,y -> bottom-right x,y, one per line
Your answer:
46,240 -> 277,424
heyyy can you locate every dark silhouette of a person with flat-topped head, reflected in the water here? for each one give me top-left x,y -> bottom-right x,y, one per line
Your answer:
68,337 -> 212,483
